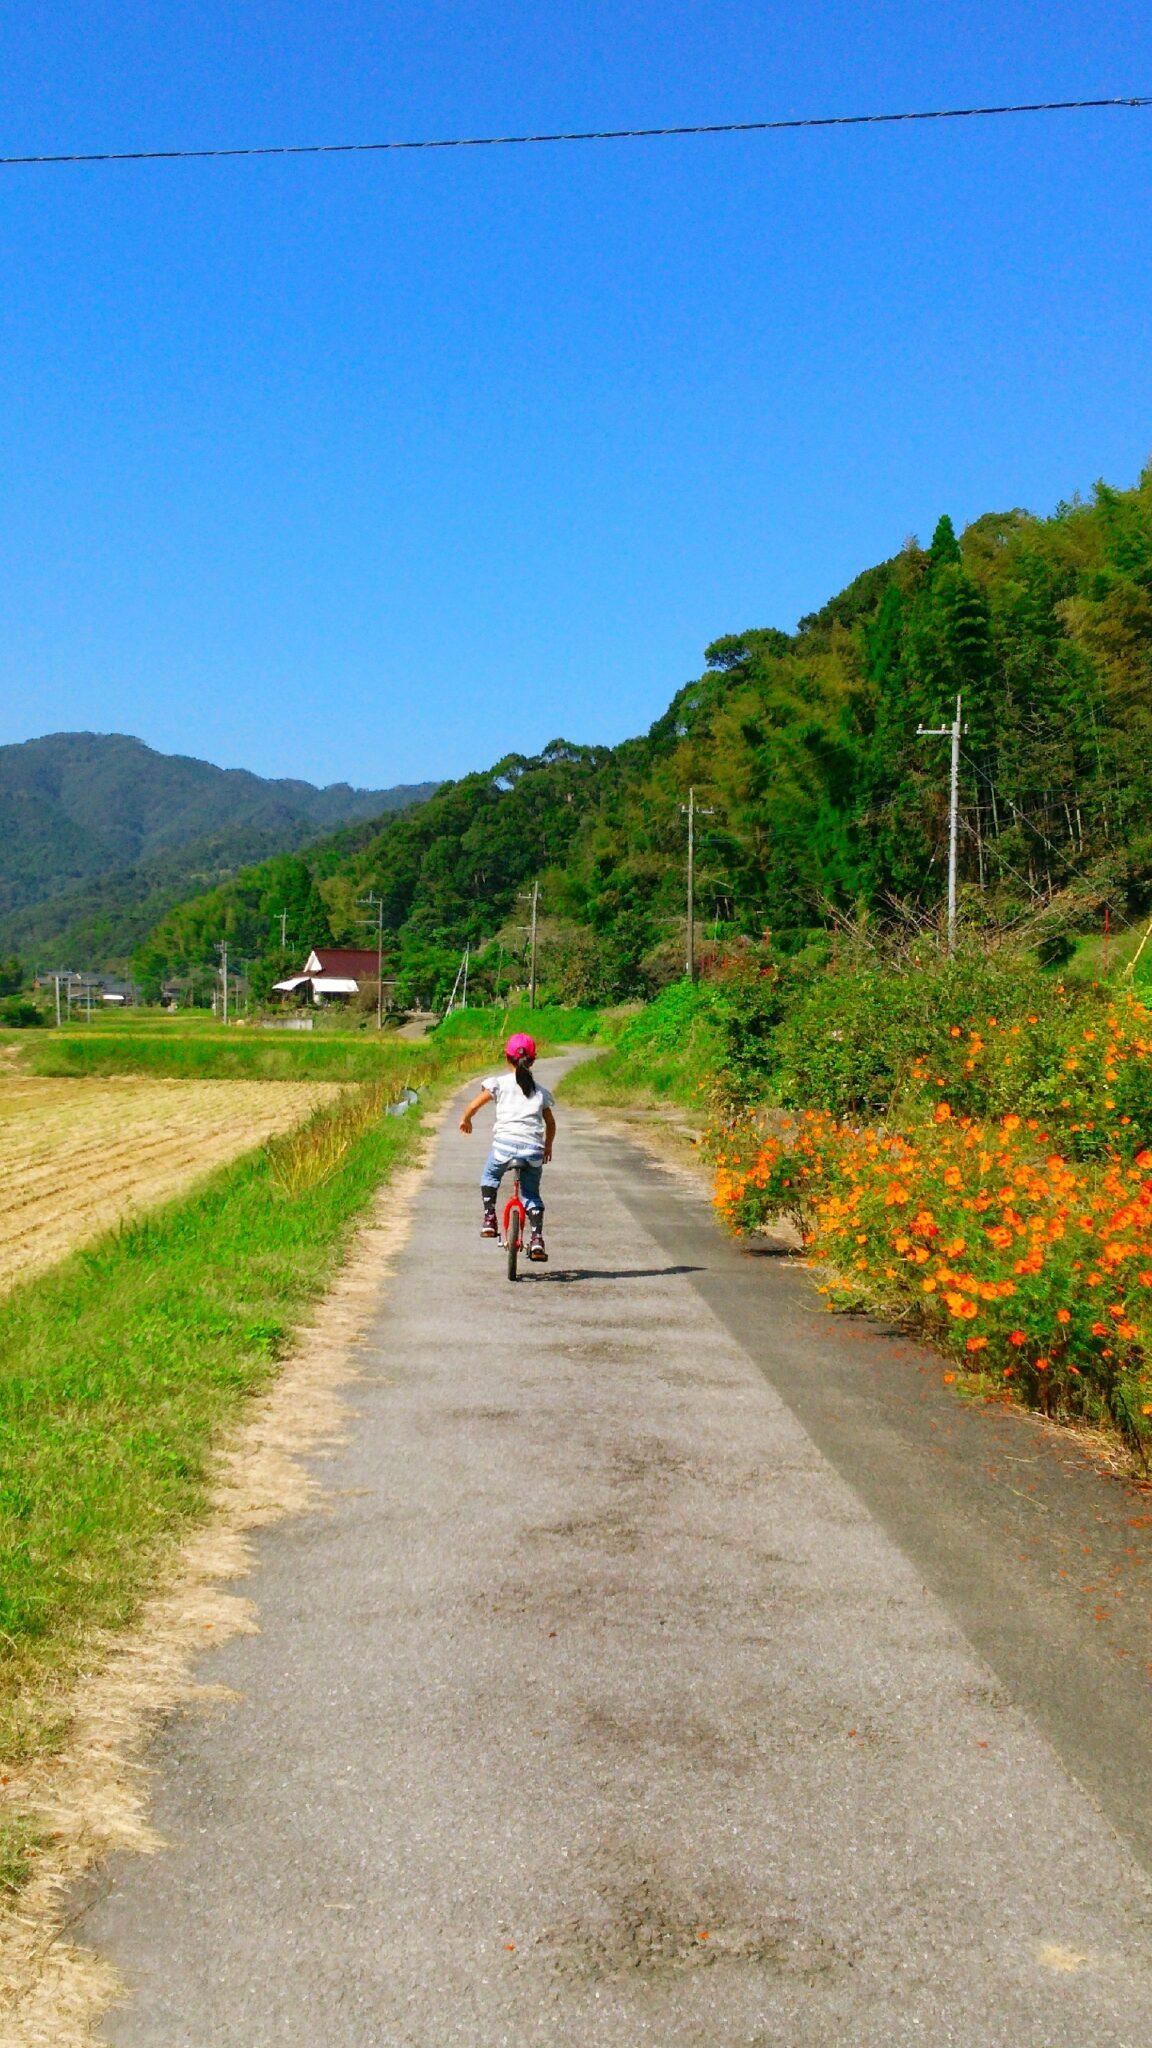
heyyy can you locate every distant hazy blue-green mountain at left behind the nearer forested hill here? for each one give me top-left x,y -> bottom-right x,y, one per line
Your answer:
0,733 -> 437,969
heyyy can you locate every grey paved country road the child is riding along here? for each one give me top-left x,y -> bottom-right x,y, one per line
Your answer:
78,1064 -> 1152,2048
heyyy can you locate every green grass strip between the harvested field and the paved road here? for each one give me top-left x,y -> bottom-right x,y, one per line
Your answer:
0,1090 -> 420,1761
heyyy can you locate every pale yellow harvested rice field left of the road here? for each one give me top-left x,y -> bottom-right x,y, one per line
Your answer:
0,1073 -> 340,1290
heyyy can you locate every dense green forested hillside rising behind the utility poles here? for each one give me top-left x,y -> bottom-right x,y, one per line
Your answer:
137,469 -> 1152,999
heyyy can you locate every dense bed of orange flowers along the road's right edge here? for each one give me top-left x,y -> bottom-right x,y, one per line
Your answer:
715,1102 -> 1152,1454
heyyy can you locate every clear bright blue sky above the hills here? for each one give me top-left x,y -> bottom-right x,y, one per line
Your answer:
0,0 -> 1152,784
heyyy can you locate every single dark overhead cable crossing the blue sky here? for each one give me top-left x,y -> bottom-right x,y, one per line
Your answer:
0,94 -> 1152,170
